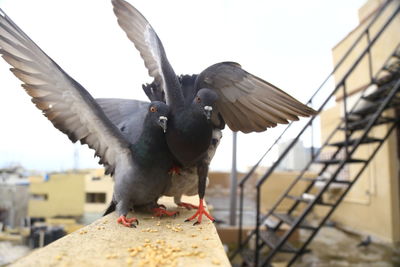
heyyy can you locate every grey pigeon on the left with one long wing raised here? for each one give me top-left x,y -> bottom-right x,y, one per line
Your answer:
0,9 -> 177,227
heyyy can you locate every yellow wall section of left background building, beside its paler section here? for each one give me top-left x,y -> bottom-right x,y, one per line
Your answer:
28,172 -> 86,218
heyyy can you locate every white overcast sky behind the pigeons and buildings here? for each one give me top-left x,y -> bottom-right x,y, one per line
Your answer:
0,0 -> 365,171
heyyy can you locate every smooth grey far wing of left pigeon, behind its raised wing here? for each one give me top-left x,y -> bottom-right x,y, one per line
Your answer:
96,98 -> 150,144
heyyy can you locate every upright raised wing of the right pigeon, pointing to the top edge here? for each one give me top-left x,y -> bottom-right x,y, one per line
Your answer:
112,0 -> 184,108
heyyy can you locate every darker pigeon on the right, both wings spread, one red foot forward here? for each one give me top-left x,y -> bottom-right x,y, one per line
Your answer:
112,0 -> 316,224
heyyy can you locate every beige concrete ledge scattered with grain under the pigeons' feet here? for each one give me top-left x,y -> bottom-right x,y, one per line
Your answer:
11,197 -> 231,266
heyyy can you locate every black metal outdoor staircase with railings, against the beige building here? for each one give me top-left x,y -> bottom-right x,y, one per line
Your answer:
230,0 -> 400,266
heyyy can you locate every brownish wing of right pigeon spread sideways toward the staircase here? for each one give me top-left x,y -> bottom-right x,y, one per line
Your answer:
195,62 -> 316,133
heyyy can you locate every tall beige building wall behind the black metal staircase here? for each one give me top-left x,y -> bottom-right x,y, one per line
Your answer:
321,0 -> 400,242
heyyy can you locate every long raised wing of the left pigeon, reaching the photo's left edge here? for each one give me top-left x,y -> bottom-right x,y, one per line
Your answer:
0,9 -> 134,174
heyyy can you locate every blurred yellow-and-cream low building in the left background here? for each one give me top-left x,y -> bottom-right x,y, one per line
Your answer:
28,169 -> 113,222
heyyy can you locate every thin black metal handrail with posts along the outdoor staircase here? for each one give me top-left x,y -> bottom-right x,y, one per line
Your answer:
231,0 -> 400,264
